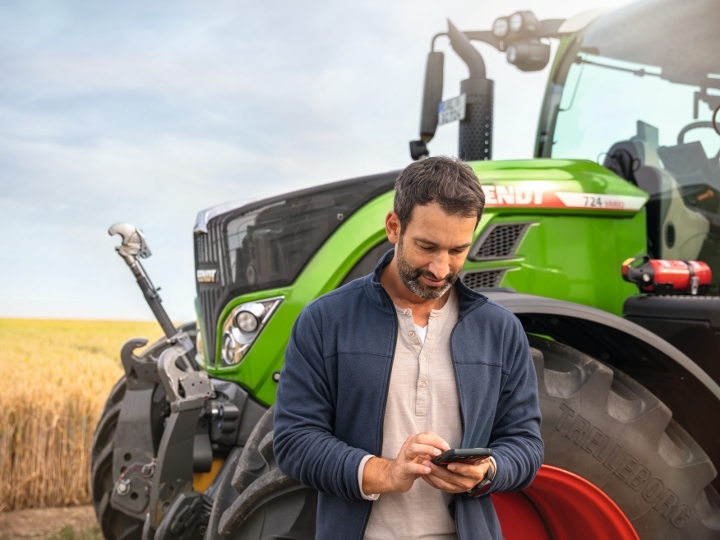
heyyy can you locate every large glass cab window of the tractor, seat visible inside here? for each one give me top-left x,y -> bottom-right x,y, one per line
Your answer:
538,0 -> 720,293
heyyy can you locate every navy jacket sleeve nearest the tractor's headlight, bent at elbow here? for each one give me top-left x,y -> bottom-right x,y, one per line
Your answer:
273,304 -> 367,499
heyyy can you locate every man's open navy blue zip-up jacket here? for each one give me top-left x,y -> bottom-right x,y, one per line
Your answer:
274,250 -> 543,540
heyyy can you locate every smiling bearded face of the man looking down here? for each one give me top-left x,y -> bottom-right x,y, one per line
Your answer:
388,203 -> 477,299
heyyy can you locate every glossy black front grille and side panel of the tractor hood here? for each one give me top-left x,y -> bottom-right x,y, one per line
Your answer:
195,172 -> 398,365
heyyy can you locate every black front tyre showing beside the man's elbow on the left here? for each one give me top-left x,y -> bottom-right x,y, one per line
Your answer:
211,407 -> 317,540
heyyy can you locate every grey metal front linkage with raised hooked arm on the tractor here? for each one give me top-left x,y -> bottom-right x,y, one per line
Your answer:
108,223 -> 264,540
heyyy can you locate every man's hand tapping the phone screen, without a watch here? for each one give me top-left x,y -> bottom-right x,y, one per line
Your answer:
362,431 -> 450,494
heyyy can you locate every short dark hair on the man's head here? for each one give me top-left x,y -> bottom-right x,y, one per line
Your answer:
394,156 -> 485,229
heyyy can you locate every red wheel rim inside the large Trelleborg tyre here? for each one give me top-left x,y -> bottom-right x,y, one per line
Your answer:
492,465 -> 640,540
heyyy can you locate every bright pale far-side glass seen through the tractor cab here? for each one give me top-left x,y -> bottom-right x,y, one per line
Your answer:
552,51 -> 720,163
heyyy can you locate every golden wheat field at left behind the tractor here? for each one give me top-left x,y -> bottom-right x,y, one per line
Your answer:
0,319 -> 162,512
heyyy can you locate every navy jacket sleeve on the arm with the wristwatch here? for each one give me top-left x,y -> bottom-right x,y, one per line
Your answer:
489,317 -> 544,492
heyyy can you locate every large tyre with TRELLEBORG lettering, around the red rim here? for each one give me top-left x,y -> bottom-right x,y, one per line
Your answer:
529,336 -> 720,540
